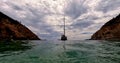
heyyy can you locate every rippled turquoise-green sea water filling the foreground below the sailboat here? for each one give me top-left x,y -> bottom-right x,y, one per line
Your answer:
0,40 -> 120,63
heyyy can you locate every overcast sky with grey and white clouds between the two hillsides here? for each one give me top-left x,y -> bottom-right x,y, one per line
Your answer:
0,0 -> 120,40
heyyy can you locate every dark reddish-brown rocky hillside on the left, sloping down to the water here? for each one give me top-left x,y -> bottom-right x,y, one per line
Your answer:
0,12 -> 39,40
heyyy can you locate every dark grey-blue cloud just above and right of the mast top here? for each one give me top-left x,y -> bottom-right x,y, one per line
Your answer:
65,0 -> 87,19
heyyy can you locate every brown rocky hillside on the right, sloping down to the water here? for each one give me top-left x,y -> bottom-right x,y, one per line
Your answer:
91,15 -> 120,40
